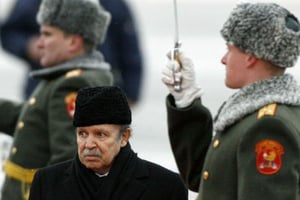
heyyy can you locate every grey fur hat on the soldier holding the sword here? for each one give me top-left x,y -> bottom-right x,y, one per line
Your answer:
221,3 -> 300,68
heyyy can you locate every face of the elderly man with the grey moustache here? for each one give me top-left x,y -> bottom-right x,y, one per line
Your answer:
77,124 -> 130,174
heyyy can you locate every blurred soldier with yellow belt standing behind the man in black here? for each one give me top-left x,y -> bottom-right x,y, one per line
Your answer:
0,0 -> 112,200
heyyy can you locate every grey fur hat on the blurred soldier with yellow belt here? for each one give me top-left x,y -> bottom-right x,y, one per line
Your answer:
37,0 -> 111,46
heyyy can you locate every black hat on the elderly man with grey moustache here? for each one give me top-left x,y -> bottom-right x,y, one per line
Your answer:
73,86 -> 131,127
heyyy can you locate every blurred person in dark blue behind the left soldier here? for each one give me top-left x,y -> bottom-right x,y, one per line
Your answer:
0,0 -> 144,105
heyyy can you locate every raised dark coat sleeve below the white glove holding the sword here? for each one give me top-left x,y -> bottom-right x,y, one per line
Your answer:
166,95 -> 213,191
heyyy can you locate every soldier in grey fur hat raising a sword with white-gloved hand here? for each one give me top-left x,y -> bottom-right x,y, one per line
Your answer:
162,3 -> 300,200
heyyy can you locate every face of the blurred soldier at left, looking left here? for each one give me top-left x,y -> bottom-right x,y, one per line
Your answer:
38,25 -> 71,67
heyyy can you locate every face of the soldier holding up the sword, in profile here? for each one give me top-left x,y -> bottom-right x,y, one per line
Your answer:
221,43 -> 249,89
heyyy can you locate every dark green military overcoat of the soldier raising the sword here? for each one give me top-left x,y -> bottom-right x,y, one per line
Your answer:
167,74 -> 300,200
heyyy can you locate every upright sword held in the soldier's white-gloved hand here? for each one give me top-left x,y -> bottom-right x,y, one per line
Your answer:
171,0 -> 182,92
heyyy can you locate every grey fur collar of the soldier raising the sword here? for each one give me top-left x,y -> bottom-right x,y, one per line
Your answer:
214,74 -> 300,131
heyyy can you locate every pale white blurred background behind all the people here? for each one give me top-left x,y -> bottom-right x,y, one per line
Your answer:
0,0 -> 300,199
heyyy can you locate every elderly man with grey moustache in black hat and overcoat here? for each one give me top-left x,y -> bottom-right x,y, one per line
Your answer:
30,86 -> 187,200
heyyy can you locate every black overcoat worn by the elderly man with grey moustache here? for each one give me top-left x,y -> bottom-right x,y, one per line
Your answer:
30,145 -> 187,200
